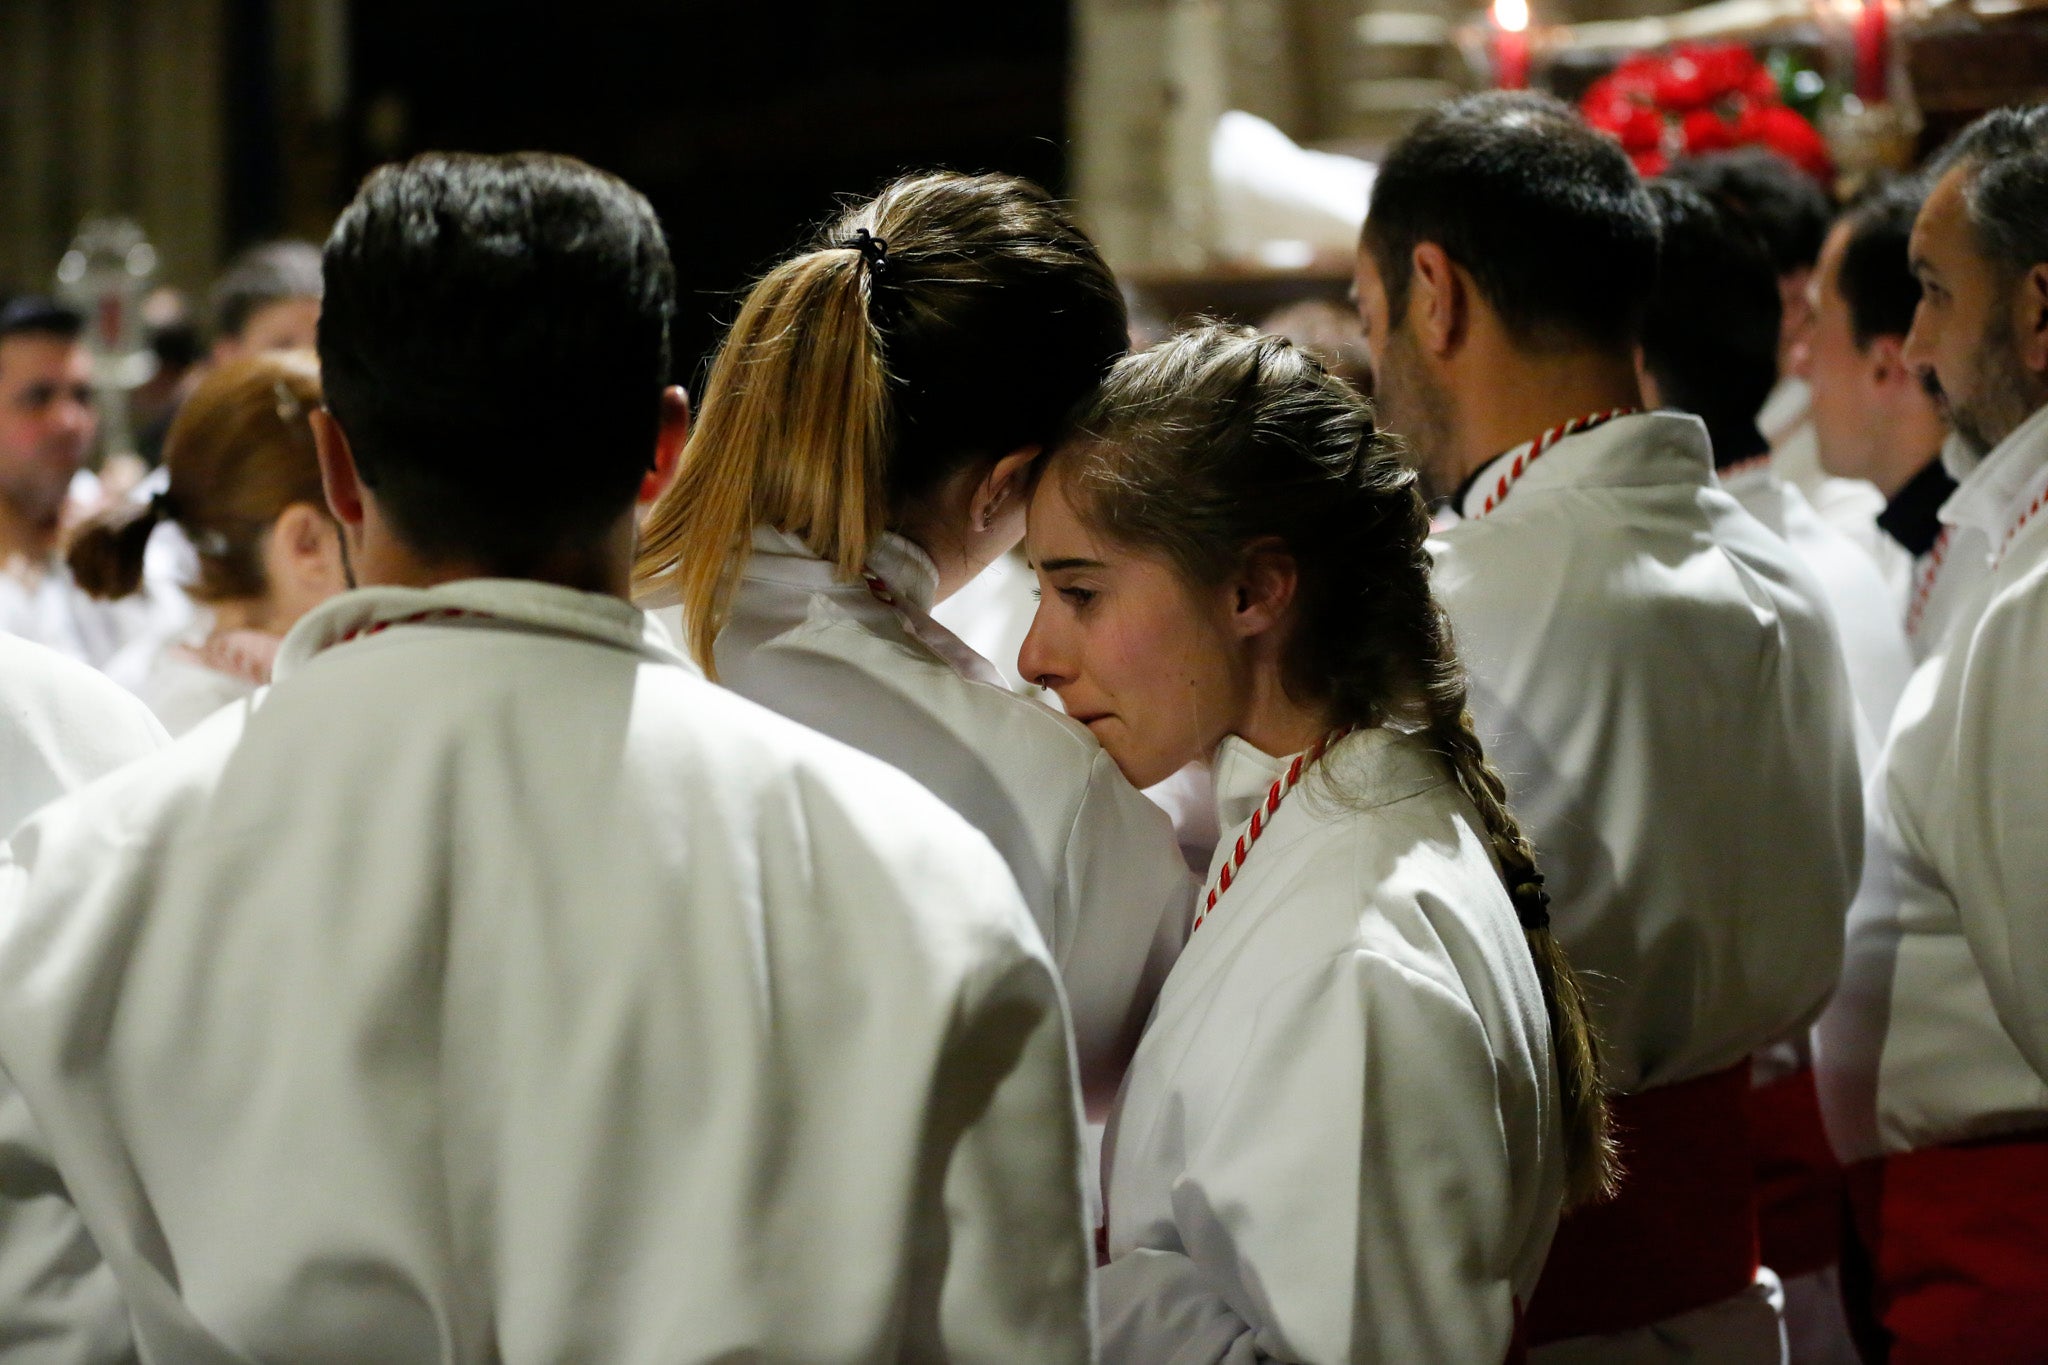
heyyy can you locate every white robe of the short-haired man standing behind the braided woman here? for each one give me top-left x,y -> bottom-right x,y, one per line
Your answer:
1434,413 -> 1862,1361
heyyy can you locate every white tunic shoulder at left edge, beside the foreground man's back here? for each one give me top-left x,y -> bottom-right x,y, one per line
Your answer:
0,634 -> 166,839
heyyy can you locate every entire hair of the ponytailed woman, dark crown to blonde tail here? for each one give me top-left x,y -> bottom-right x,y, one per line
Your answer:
635,172 -> 1128,671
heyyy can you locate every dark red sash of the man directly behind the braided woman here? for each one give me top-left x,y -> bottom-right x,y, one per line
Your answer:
1526,1062 -> 1757,1347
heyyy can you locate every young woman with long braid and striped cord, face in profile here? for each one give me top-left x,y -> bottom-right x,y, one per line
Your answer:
1020,327 -> 1614,1363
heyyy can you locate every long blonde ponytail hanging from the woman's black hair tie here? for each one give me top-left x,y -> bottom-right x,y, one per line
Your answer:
635,248 -> 889,677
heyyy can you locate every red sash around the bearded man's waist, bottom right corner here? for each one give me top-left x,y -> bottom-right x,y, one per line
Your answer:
1845,1134 -> 2048,1365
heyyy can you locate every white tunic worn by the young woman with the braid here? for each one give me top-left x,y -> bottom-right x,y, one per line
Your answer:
1096,729 -> 1563,1365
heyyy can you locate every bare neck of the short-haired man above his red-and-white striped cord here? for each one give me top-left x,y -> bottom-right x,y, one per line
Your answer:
1452,350 -> 1642,493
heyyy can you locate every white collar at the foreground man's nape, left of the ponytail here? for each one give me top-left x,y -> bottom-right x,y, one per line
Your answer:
270,579 -> 694,681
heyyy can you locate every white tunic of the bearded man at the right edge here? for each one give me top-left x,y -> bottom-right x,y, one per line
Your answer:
1815,407 -> 2048,1160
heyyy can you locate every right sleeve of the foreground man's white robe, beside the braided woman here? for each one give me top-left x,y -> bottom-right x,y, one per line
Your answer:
929,949 -> 1094,1365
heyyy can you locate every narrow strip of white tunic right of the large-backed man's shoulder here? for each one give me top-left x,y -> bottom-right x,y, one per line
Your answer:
1720,465 -> 1913,765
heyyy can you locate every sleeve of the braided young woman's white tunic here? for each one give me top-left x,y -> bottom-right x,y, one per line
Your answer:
1098,952 -> 1516,1365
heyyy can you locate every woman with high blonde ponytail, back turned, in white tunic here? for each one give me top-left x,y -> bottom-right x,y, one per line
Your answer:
637,174 -> 1192,1111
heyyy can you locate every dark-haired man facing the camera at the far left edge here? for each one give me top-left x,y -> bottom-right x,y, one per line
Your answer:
0,295 -> 152,667
